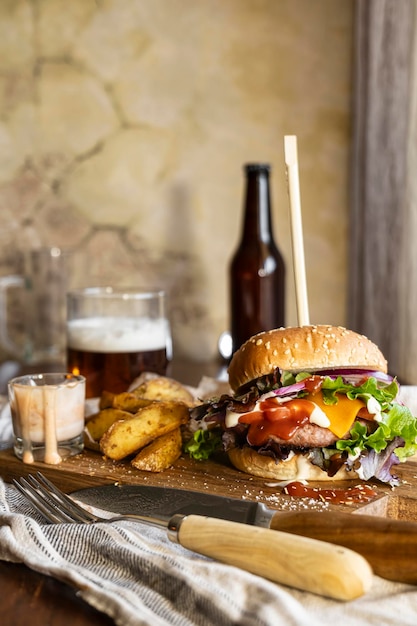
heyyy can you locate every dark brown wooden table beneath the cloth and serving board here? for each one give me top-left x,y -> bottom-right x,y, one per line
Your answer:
0,360 -> 224,626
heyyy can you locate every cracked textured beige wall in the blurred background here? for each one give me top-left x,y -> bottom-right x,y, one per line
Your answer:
0,0 -> 353,360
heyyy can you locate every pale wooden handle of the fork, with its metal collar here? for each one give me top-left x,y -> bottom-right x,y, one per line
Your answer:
168,515 -> 372,600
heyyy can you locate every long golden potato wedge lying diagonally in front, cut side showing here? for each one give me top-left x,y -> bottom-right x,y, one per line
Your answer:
100,402 -> 188,461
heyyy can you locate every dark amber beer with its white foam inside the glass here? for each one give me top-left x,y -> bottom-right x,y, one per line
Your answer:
67,317 -> 170,398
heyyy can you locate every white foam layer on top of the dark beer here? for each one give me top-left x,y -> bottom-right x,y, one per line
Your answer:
67,317 -> 171,352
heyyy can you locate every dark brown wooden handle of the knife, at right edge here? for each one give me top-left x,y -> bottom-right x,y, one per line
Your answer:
270,511 -> 417,584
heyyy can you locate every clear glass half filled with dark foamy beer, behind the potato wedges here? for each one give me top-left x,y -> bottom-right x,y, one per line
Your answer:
67,287 -> 172,398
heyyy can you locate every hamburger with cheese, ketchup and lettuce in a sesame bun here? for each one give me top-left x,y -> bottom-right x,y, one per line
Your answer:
186,325 -> 417,485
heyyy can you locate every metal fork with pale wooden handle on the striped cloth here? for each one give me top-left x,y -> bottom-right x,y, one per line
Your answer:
13,472 -> 372,600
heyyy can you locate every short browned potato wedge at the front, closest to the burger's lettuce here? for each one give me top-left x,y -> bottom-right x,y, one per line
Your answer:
132,428 -> 182,472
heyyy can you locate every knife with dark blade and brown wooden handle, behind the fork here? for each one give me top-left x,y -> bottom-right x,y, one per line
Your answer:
71,484 -> 417,584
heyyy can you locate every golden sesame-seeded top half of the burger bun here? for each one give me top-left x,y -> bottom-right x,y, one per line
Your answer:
228,325 -> 387,391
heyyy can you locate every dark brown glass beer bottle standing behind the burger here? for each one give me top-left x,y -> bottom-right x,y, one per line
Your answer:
230,163 -> 285,352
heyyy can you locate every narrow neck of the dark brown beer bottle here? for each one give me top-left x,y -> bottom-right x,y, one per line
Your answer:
242,166 -> 274,243
